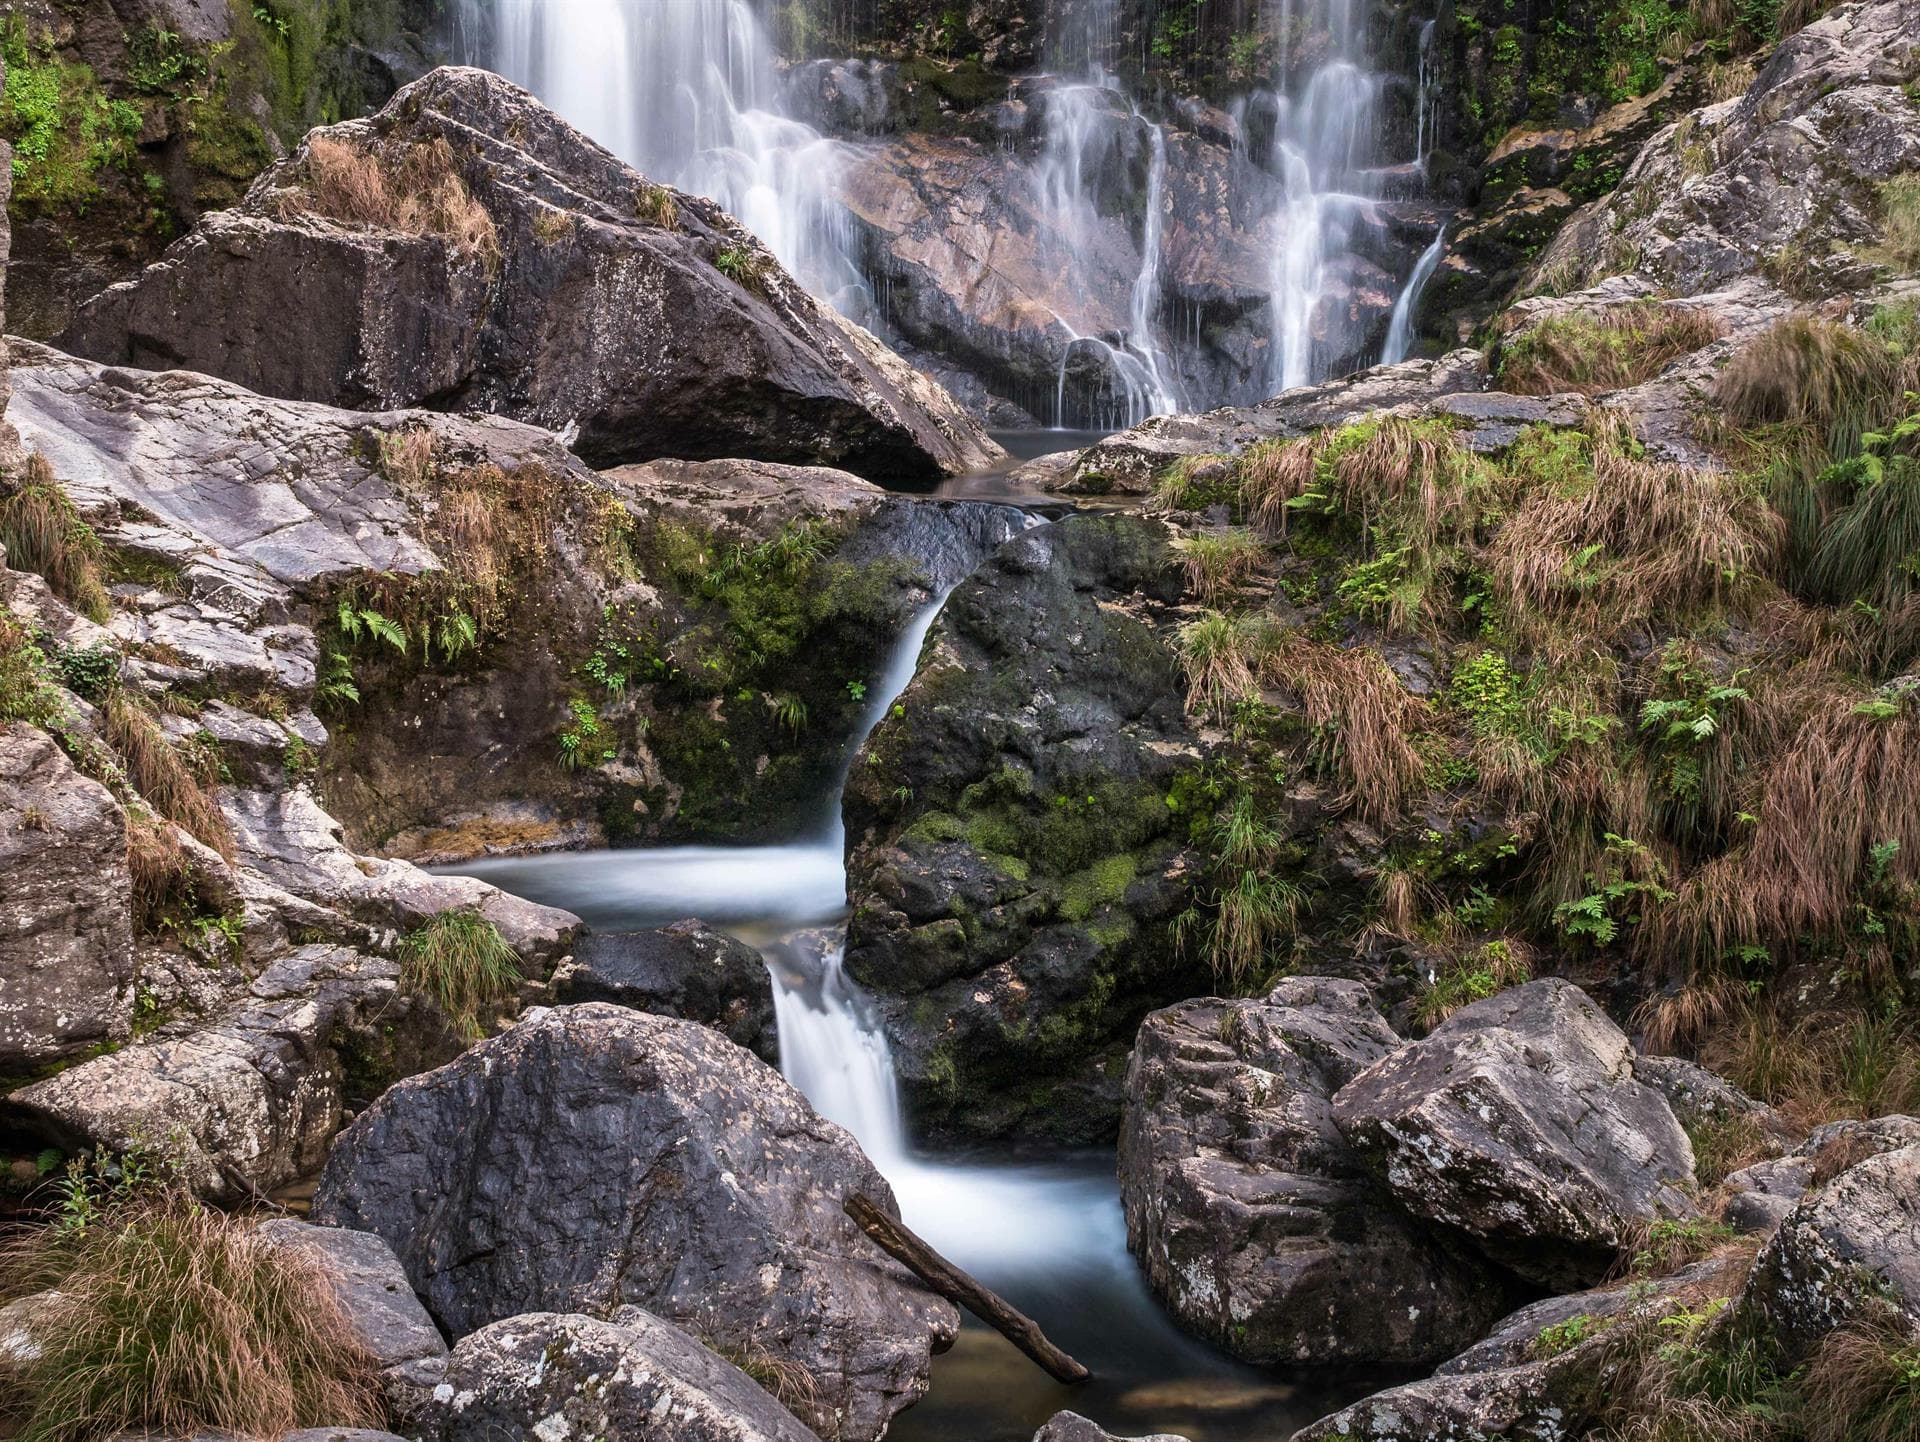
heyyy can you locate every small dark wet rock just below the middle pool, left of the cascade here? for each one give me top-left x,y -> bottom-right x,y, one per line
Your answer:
551,920 -> 780,1062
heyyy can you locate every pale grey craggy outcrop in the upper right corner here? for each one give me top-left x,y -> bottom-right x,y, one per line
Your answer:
1534,0 -> 1920,298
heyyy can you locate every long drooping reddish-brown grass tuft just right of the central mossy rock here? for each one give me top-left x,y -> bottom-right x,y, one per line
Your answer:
1265,634 -> 1427,828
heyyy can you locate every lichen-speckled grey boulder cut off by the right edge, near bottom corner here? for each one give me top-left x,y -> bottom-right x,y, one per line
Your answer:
1736,1146 -> 1920,1365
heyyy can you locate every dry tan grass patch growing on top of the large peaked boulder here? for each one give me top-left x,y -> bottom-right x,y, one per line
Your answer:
282,134 -> 501,271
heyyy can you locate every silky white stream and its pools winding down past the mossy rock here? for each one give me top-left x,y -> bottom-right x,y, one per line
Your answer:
456,603 -> 1386,1442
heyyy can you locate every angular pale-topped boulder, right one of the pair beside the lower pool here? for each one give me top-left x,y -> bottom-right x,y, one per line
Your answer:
1332,979 -> 1695,1288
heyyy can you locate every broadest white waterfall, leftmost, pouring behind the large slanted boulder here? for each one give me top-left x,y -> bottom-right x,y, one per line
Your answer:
453,0 -> 872,319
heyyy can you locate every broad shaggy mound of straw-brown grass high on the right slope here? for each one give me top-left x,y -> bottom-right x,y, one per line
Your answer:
1488,422 -> 1786,643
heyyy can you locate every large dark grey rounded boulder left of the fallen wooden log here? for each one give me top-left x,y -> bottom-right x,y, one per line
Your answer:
313,1002 -> 958,1442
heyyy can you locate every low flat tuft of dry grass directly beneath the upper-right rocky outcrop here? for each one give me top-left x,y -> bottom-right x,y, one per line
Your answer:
1498,301 -> 1724,396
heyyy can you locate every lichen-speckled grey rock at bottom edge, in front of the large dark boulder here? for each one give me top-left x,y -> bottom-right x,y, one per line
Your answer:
420,1308 -> 831,1442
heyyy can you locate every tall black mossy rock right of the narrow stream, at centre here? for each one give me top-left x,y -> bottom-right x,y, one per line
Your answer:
845,517 -> 1200,1141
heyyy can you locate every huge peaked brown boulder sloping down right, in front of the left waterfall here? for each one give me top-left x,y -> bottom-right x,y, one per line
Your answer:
58,67 -> 998,480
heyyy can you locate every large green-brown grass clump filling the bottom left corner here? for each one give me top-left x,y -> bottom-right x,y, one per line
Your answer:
0,1166 -> 384,1442
